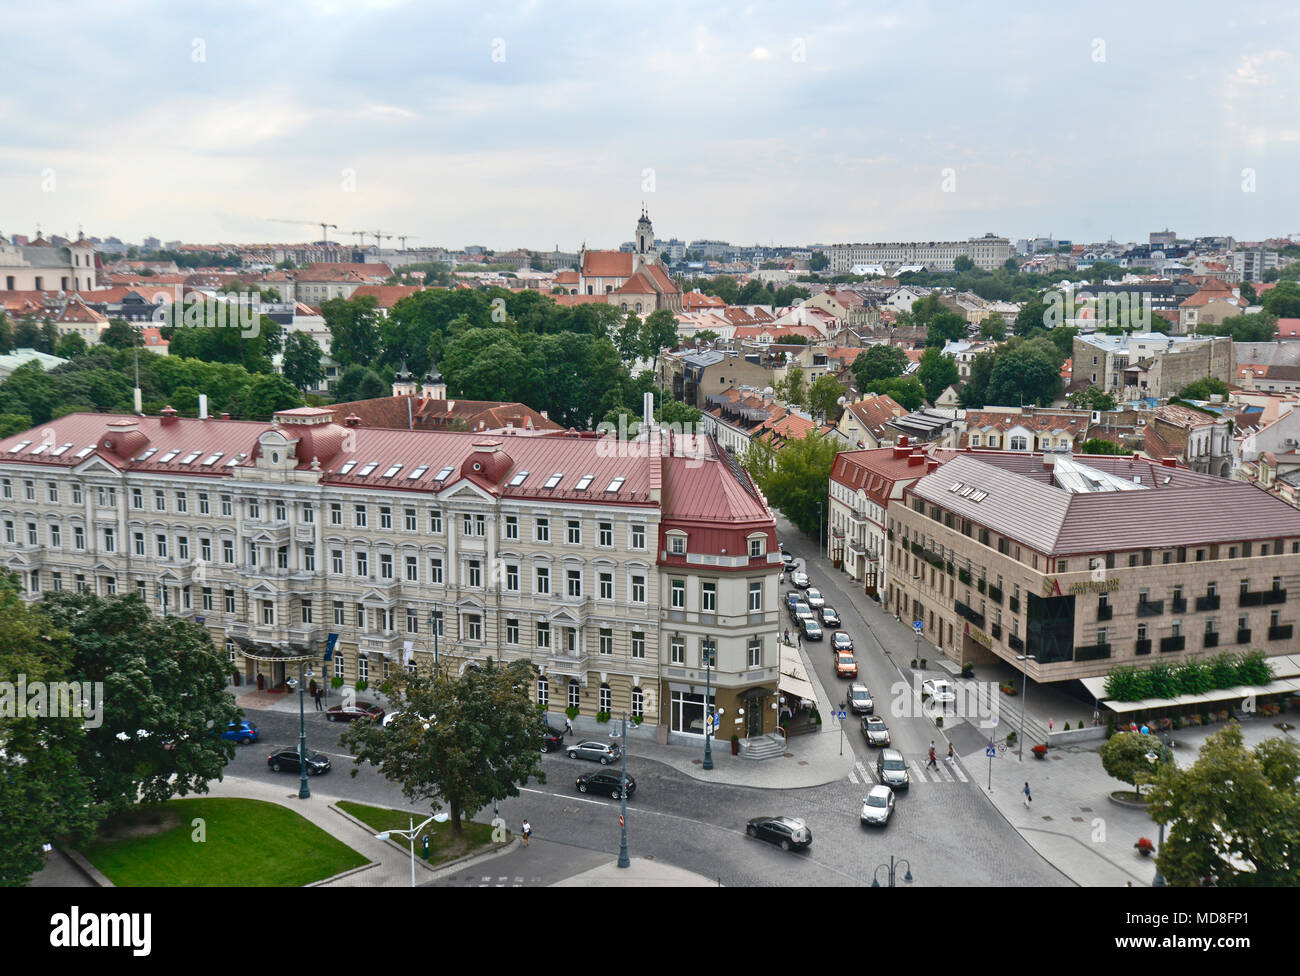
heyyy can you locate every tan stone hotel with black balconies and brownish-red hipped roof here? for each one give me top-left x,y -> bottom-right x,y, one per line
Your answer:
885,452 -> 1300,681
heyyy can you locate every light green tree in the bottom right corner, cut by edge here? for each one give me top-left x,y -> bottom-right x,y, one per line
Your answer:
1148,723 -> 1300,888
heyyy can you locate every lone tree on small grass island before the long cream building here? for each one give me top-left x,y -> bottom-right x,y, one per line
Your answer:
342,658 -> 546,836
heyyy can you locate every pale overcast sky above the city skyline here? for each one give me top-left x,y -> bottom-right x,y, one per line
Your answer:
0,0 -> 1300,250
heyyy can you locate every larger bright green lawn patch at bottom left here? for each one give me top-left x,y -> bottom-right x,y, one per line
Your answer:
82,797 -> 368,888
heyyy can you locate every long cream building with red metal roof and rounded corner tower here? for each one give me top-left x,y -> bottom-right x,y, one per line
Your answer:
0,408 -> 781,737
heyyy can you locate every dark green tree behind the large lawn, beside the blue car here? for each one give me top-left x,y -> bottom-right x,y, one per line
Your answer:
40,590 -> 239,812
